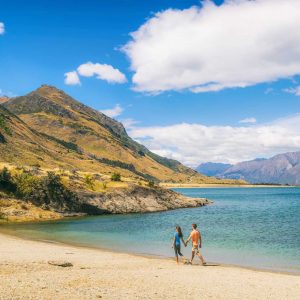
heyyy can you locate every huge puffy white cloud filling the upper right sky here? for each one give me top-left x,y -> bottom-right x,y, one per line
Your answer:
123,0 -> 300,93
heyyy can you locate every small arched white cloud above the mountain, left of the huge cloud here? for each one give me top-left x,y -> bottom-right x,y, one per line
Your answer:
77,62 -> 127,83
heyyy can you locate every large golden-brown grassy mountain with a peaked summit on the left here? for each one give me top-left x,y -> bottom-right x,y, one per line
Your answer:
0,85 -> 238,183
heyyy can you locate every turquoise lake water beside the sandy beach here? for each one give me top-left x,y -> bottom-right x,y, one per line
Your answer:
3,188 -> 300,274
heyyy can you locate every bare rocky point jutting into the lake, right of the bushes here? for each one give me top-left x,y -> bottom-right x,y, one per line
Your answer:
80,186 -> 212,214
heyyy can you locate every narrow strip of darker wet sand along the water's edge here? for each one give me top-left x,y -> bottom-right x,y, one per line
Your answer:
0,230 -> 300,277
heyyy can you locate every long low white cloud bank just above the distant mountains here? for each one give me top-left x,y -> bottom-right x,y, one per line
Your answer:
128,114 -> 300,166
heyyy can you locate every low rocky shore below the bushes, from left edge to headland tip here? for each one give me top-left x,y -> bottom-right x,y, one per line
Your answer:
0,185 -> 212,224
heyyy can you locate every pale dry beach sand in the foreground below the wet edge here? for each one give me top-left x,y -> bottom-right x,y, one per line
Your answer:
0,234 -> 300,300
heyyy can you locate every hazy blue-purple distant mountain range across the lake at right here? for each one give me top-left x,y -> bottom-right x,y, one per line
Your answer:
197,151 -> 300,185
